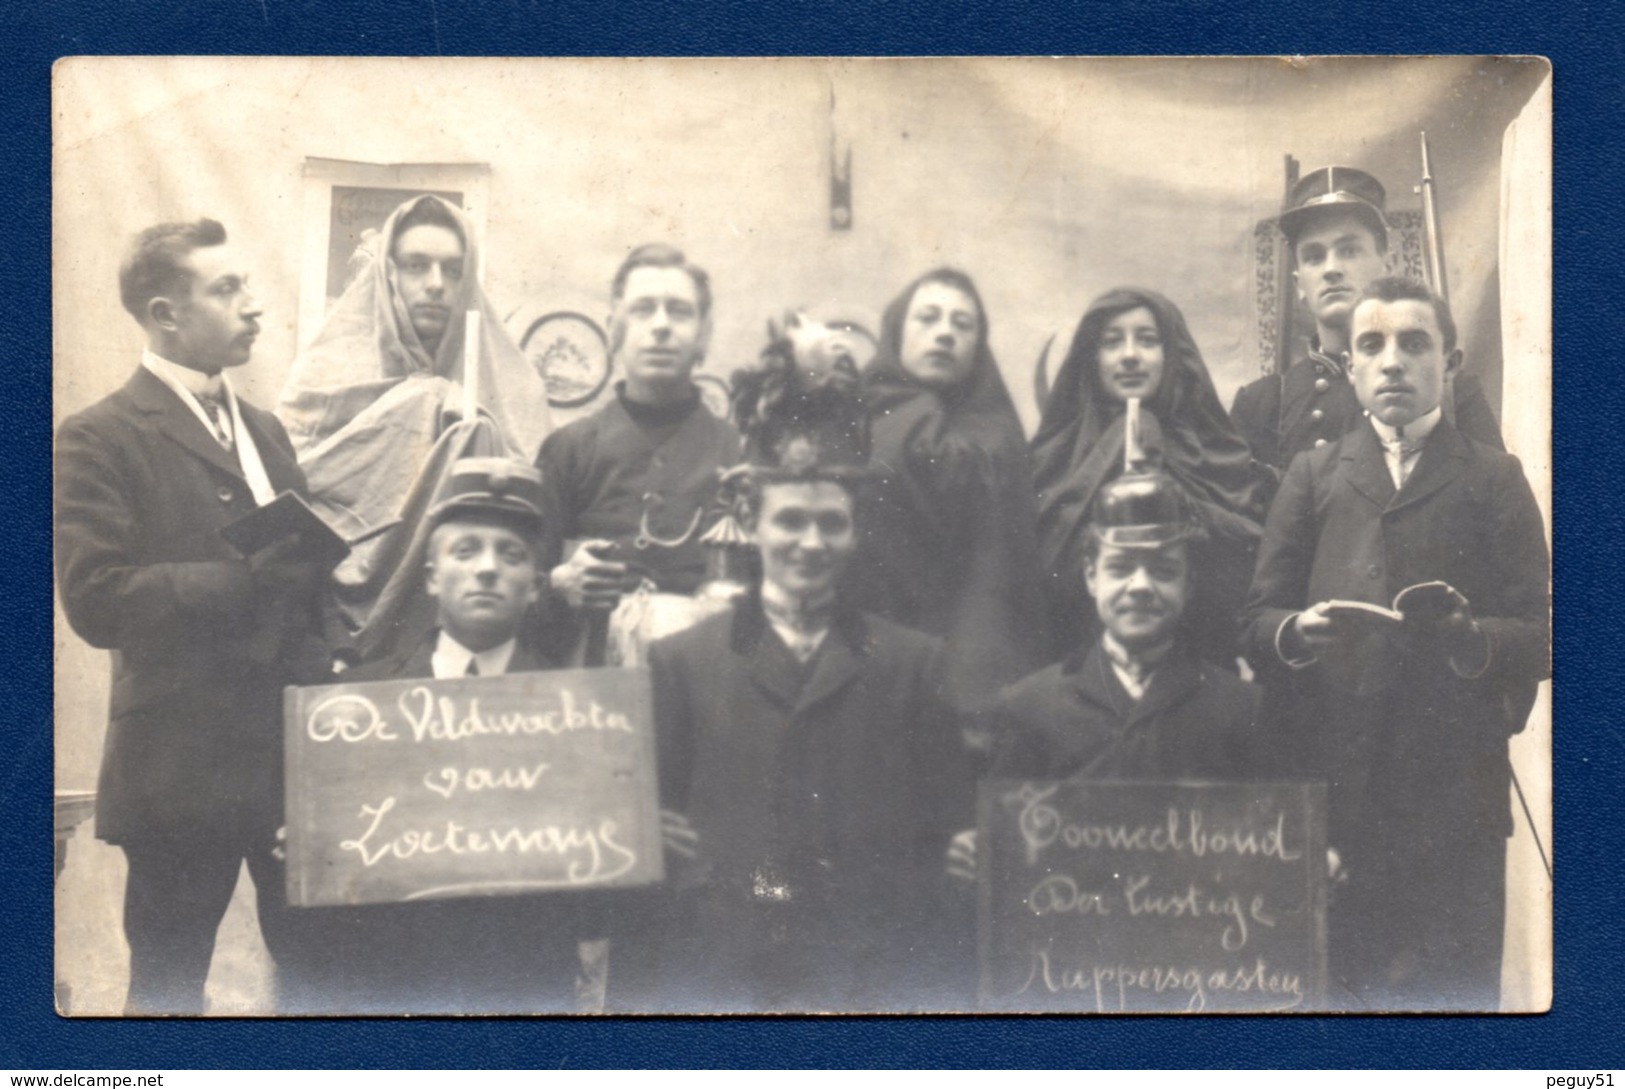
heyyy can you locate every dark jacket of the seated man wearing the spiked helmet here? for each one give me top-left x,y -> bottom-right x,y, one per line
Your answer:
991,640 -> 1268,780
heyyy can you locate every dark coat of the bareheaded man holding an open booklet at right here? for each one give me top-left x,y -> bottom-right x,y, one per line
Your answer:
1246,421 -> 1550,877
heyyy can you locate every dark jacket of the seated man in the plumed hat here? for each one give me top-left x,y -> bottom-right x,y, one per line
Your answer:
650,600 -> 972,1009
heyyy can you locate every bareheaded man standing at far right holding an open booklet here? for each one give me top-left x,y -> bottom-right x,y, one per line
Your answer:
1246,278 -> 1550,1009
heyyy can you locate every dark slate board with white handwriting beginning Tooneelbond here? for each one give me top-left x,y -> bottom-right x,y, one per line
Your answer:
978,780 -> 1326,1013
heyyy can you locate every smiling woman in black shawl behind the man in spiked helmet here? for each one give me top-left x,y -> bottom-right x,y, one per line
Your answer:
1032,288 -> 1264,666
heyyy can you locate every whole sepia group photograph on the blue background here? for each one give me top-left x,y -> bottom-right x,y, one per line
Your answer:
50,55 -> 1554,1017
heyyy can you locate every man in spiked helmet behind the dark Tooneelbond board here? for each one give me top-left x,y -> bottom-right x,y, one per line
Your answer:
991,473 -> 1261,789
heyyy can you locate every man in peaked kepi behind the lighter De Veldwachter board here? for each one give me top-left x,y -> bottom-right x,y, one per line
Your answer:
284,458 -> 580,1013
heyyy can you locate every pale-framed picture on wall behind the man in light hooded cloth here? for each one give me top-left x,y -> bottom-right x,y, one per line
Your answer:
299,158 -> 491,348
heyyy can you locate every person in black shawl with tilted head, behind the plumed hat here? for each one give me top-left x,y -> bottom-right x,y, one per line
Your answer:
853,268 -> 1043,709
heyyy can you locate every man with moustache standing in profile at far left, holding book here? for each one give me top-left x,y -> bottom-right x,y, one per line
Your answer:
55,219 -> 332,1014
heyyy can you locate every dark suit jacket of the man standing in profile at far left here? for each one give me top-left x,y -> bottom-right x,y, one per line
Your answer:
55,367 -> 330,844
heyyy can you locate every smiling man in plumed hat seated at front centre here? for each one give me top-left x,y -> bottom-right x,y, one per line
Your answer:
650,380 -> 969,1011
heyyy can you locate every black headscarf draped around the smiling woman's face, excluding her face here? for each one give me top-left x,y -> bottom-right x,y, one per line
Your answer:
1032,288 -> 1264,653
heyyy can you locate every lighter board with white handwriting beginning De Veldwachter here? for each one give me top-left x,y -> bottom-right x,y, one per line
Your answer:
284,670 -> 661,907
